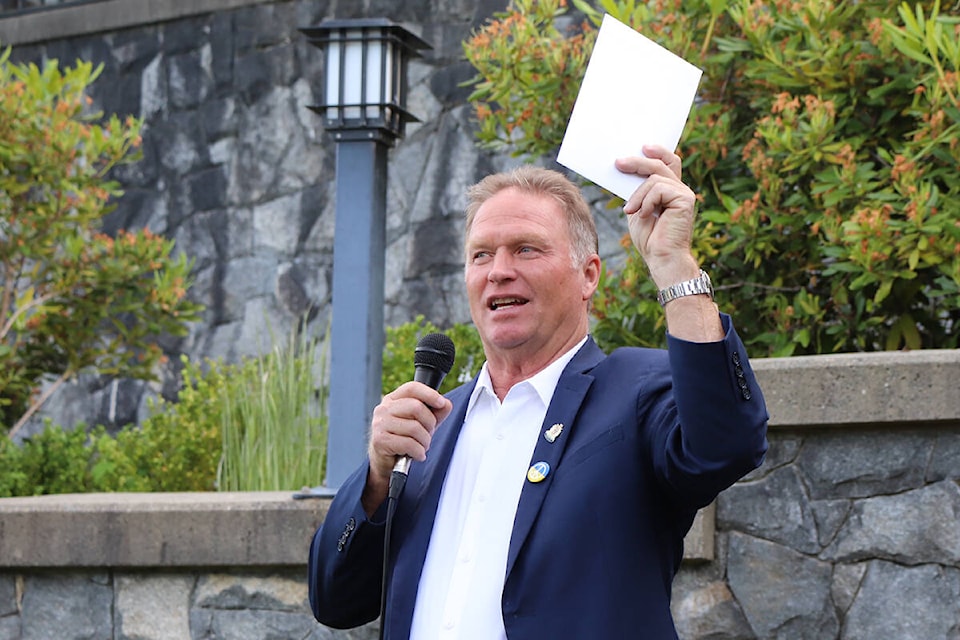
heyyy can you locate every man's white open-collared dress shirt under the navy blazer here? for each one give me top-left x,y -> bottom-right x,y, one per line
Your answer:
410,337 -> 586,640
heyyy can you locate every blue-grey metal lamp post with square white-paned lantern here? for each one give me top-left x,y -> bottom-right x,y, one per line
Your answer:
302,18 -> 430,495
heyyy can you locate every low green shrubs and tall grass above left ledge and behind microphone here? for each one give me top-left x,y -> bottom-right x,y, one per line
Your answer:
0,316 -> 484,497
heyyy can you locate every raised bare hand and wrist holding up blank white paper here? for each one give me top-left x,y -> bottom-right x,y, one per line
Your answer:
557,15 -> 723,342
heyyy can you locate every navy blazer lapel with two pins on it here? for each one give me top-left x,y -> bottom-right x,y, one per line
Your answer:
506,338 -> 605,576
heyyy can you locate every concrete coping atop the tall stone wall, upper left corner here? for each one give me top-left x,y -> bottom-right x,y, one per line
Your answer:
0,0 -> 266,47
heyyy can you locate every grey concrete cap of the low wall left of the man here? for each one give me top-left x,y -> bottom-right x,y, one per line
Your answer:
0,491 -> 329,567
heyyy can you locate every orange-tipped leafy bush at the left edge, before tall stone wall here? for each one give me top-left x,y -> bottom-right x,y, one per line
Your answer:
0,50 -> 199,436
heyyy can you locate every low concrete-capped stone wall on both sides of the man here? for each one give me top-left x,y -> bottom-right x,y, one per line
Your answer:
0,351 -> 960,640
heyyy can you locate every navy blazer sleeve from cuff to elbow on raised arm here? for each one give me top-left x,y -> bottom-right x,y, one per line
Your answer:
654,314 -> 769,508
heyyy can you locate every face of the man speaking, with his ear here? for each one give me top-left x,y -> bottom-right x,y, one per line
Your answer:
466,188 -> 600,366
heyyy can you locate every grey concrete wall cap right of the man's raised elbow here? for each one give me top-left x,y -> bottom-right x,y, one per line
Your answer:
751,349 -> 960,427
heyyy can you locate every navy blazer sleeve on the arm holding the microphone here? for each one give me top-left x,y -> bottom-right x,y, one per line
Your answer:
307,464 -> 386,629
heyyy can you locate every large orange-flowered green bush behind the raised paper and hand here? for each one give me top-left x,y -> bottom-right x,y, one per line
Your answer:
464,0 -> 960,355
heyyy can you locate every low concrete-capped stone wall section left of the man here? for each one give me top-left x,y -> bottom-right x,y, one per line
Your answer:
0,493 -> 352,640
